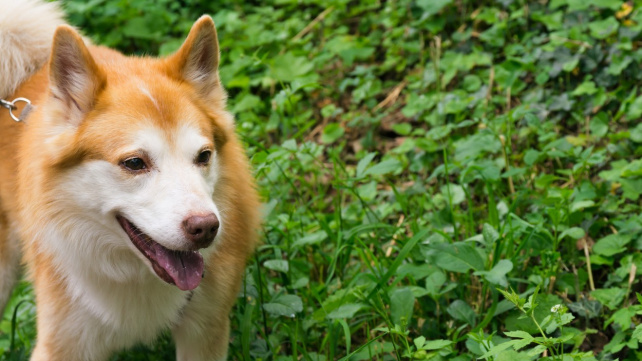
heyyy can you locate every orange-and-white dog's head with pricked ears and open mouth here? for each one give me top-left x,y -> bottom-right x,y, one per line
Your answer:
43,16 -> 233,290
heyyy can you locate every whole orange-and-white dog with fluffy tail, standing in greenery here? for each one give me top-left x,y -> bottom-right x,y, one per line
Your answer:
0,0 -> 260,361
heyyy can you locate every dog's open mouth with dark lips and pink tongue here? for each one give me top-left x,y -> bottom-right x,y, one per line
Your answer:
116,216 -> 203,291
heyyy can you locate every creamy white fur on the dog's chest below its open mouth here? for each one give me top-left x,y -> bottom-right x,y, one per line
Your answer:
33,221 -> 192,355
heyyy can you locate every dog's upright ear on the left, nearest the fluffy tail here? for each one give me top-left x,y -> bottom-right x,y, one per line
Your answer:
49,25 -> 106,125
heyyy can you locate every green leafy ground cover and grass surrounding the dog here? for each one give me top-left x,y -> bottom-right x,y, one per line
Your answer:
0,0 -> 642,361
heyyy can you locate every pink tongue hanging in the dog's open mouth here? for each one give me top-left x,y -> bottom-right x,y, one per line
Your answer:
153,243 -> 203,291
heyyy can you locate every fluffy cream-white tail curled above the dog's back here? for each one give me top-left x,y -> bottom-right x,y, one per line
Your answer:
0,0 -> 65,99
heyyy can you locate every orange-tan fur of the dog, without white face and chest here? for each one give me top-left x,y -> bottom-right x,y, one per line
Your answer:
0,7 -> 259,361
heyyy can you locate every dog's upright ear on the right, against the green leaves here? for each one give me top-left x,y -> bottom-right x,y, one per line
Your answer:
167,15 -> 222,97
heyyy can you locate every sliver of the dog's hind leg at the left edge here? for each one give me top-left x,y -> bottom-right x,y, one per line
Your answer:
0,217 -> 20,315
